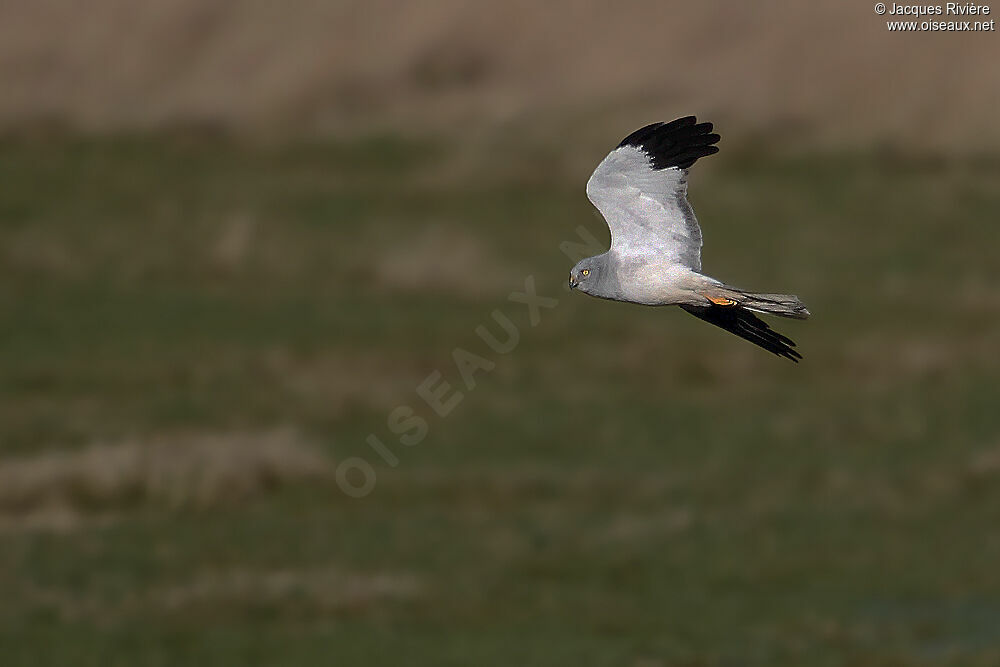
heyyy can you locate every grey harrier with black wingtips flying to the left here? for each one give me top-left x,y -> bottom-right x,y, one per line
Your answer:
569,116 -> 809,362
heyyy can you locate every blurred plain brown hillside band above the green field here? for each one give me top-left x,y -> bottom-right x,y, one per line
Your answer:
0,0 -> 1000,151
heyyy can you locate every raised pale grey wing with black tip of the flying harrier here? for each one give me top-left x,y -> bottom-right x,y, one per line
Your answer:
587,116 -> 719,271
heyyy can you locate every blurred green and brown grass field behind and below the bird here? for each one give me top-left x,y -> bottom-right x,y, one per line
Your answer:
0,133 -> 1000,666
